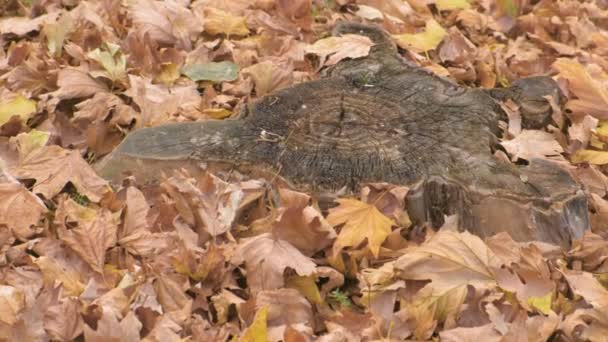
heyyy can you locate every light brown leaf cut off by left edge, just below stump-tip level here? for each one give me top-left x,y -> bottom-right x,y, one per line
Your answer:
0,183 -> 47,240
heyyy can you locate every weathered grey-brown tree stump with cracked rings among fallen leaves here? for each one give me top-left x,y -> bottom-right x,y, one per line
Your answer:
98,23 -> 588,246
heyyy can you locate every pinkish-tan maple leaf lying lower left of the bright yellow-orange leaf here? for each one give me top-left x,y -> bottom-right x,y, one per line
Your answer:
232,233 -> 316,291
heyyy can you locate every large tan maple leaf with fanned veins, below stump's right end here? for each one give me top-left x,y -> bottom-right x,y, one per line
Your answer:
395,229 -> 502,290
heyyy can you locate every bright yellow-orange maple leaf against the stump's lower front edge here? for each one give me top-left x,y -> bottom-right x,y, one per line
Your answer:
327,199 -> 395,257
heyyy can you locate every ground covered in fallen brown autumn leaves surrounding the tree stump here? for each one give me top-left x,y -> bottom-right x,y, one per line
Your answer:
0,0 -> 608,342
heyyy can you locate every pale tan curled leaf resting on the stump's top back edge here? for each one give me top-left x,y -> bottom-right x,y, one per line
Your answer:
305,34 -> 374,66
